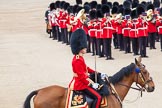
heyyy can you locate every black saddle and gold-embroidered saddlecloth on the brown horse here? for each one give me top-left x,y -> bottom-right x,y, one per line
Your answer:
65,74 -> 109,108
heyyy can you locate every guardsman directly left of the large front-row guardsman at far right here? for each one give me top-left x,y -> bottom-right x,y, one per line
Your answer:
129,9 -> 139,56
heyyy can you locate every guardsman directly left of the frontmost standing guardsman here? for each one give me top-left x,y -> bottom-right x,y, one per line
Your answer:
94,9 -> 104,58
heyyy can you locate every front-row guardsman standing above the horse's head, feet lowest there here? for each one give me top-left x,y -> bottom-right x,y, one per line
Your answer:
137,6 -> 148,57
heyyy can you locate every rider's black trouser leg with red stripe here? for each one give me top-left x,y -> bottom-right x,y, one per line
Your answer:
83,87 -> 102,108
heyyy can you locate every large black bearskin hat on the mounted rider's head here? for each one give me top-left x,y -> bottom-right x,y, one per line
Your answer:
70,29 -> 87,55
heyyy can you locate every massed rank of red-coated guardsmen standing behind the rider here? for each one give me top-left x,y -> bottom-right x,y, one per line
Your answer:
45,0 -> 162,60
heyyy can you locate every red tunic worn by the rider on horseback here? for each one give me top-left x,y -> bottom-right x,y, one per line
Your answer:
69,55 -> 94,90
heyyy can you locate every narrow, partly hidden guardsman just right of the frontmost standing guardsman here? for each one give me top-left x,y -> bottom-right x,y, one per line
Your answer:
111,4 -> 119,49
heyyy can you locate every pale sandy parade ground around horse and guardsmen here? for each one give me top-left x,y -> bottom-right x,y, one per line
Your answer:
0,0 -> 162,108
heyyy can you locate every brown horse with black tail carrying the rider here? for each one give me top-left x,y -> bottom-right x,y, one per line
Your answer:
24,57 -> 155,108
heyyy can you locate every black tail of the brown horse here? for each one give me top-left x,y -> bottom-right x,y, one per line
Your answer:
23,91 -> 38,108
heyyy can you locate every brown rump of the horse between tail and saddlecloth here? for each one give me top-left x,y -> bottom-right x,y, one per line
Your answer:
34,86 -> 66,108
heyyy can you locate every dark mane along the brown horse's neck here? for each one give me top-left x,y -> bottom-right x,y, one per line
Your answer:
109,63 -> 135,84
